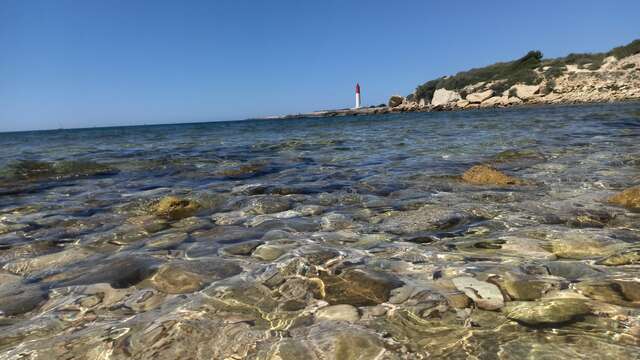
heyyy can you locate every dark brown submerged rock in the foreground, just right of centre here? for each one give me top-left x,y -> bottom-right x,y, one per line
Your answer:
320,269 -> 403,306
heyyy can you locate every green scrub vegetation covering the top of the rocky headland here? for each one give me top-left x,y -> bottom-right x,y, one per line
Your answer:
415,40 -> 640,101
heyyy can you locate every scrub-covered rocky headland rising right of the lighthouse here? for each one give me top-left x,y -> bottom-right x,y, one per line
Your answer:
389,40 -> 640,111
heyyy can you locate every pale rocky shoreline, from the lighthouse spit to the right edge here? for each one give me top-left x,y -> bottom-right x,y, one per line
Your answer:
279,48 -> 640,119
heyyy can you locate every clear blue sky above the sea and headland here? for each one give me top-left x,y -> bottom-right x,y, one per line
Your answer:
0,0 -> 640,131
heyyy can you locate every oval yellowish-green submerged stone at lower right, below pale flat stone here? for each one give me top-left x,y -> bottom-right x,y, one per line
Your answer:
505,298 -> 591,326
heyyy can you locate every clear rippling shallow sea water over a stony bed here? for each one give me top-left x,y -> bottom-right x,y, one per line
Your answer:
0,103 -> 640,359
